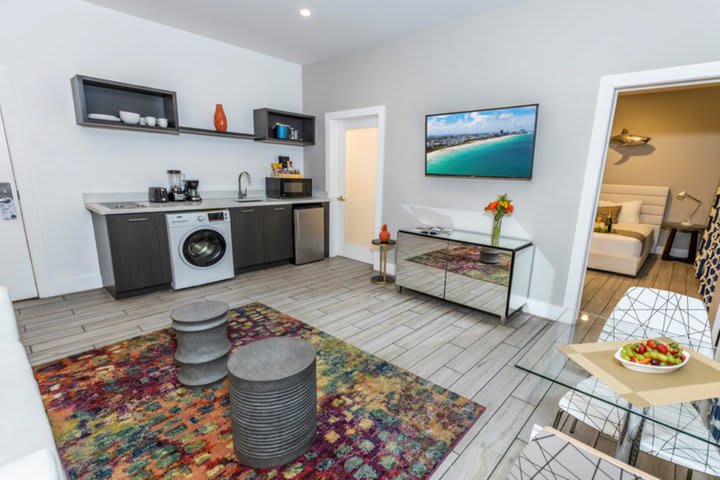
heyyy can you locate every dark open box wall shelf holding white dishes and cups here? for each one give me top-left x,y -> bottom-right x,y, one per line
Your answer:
70,75 -> 179,135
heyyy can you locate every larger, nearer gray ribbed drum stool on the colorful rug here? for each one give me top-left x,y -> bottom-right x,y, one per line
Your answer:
228,337 -> 317,468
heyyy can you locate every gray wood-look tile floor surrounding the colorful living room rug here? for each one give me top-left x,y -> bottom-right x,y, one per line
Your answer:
15,257 -> 703,480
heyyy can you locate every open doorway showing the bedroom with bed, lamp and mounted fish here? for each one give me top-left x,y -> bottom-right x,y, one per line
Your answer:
580,84 -> 720,317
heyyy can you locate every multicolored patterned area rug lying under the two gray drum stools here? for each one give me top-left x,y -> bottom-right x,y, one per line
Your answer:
35,303 -> 485,480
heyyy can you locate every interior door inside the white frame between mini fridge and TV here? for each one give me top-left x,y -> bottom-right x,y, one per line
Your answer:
335,117 -> 378,263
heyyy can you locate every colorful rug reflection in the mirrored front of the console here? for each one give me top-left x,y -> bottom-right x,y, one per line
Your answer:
408,247 -> 511,285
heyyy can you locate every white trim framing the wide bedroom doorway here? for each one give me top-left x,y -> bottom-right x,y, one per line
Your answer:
564,62 -> 720,311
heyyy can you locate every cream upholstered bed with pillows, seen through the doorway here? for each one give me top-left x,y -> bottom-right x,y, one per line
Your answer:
588,184 -> 670,276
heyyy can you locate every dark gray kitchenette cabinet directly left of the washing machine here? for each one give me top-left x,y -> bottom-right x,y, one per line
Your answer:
93,213 -> 172,298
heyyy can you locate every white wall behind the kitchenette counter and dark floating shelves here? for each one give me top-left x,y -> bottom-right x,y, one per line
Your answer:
0,0 -> 303,296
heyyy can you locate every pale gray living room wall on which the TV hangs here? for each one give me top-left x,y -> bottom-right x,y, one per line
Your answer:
303,0 -> 720,312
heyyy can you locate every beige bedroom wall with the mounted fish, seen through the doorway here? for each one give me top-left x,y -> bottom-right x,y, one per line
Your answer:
603,86 -> 720,248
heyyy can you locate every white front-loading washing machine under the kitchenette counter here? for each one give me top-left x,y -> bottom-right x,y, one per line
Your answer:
165,210 -> 235,290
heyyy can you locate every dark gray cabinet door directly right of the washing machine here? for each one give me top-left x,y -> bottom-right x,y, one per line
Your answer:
230,207 -> 264,269
